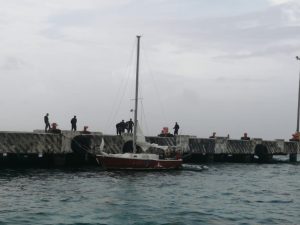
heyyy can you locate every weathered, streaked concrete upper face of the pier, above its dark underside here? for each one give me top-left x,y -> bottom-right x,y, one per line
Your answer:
0,131 -> 300,155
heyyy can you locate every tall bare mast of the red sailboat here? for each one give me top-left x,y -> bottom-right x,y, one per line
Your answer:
133,35 -> 141,153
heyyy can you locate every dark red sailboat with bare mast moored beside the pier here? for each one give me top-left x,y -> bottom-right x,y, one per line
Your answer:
96,36 -> 182,170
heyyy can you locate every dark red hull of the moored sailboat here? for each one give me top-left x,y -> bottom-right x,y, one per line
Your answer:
96,155 -> 182,170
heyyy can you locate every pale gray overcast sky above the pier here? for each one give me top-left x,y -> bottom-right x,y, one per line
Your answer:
0,0 -> 300,139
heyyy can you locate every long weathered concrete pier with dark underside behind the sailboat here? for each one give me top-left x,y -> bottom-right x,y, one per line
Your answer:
0,131 -> 300,167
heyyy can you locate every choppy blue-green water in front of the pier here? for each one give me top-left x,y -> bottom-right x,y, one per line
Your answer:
0,163 -> 300,225
